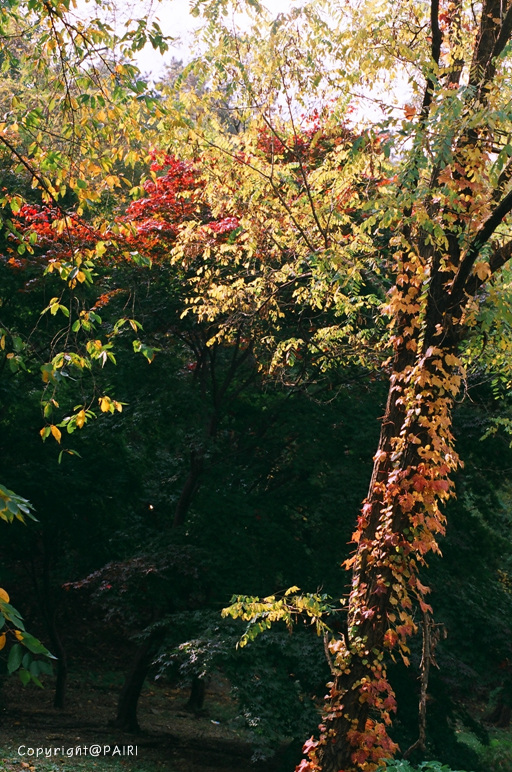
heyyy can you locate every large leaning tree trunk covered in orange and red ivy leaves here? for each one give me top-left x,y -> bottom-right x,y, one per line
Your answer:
297,0 -> 512,772
